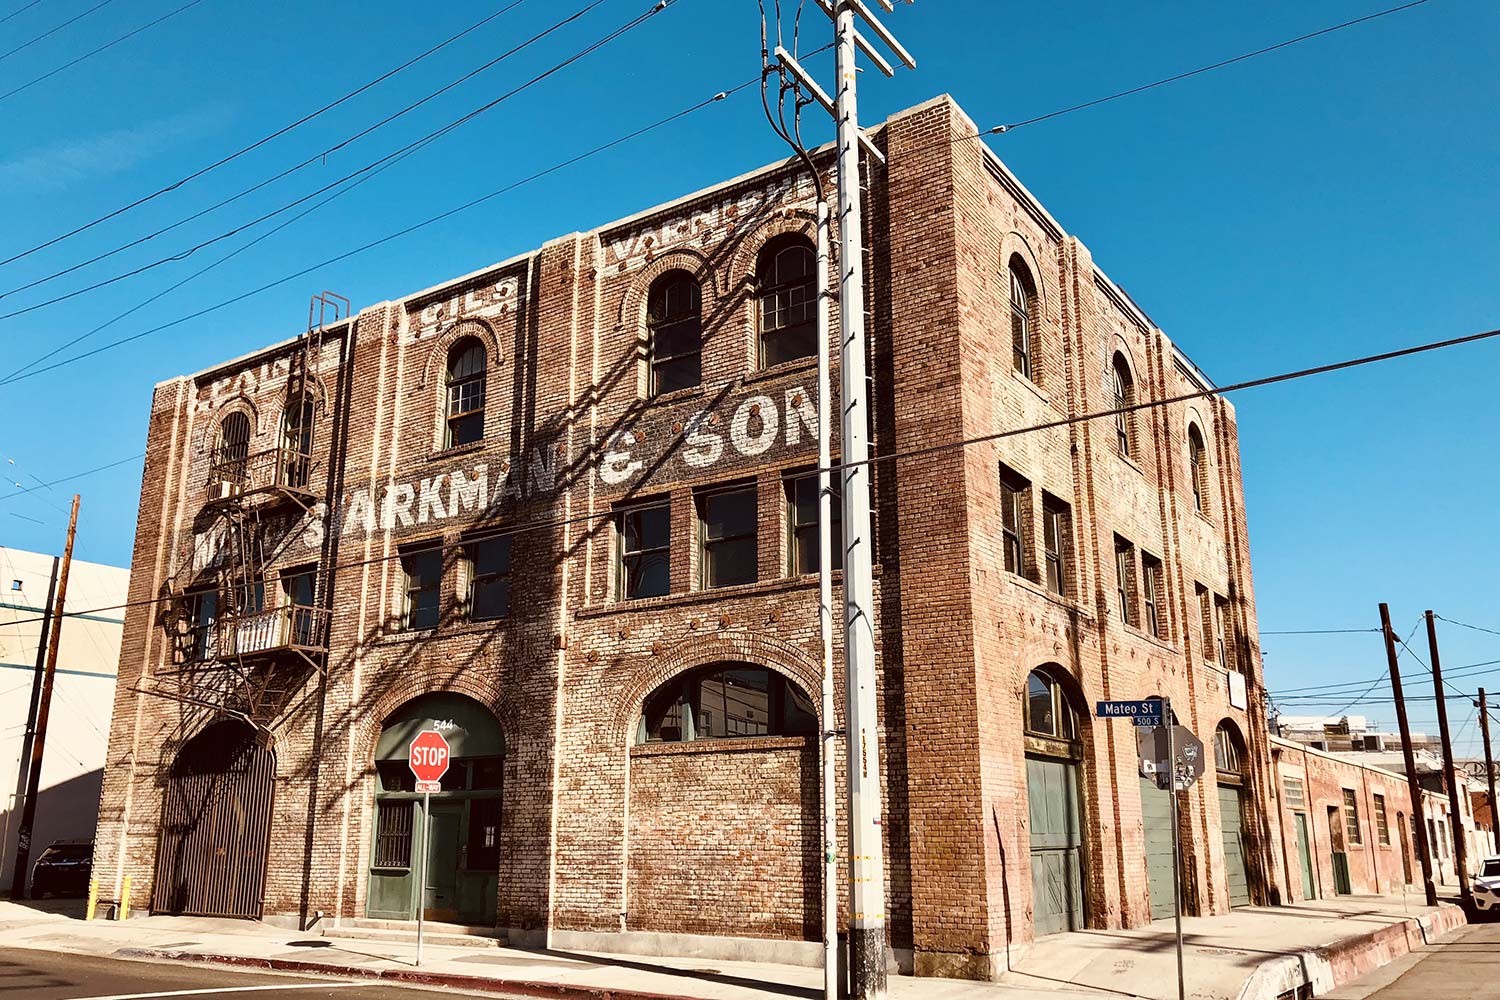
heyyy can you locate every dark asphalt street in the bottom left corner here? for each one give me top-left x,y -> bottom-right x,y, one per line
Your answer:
0,948 -> 495,1000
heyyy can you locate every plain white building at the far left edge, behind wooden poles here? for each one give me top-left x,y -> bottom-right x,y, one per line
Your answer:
0,546 -> 131,894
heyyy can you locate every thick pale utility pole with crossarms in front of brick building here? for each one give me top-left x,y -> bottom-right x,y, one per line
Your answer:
834,4 -> 887,1000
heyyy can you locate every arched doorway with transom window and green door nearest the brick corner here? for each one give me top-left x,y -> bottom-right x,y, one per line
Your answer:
1025,667 -> 1086,937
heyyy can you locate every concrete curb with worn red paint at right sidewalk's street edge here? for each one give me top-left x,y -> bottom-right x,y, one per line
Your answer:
1238,903 -> 1469,1000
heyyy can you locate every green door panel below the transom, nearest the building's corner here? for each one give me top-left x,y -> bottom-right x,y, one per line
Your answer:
1026,757 -> 1083,937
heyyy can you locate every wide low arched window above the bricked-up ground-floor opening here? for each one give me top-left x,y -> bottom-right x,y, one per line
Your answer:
636,664 -> 818,744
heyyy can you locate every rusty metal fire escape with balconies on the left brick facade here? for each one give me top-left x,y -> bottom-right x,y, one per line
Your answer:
151,291 -> 350,732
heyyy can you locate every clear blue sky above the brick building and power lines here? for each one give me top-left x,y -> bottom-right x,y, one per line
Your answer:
0,0 -> 1500,742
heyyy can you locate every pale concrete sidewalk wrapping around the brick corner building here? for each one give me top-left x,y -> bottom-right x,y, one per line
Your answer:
0,897 -> 1464,1000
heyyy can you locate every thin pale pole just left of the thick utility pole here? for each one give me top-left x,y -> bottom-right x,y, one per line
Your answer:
818,199 -> 840,1000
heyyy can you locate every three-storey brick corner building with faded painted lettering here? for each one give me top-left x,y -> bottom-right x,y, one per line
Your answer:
96,97 -> 1281,978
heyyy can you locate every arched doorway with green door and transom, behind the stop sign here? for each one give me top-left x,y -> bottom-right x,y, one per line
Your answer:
365,694 -> 506,927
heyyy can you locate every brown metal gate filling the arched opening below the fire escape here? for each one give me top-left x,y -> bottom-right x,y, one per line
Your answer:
152,721 -> 276,918
